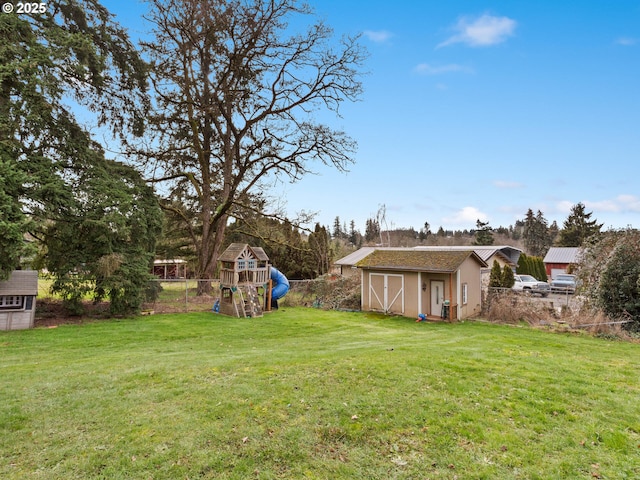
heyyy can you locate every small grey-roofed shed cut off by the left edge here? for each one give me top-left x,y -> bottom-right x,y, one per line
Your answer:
0,270 -> 38,330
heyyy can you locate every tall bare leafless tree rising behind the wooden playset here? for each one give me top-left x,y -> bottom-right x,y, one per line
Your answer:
138,0 -> 365,286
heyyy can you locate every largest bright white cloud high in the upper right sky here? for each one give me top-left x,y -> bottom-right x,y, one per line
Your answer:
436,14 -> 518,48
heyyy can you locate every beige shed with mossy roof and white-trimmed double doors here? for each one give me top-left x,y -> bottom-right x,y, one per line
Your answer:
356,248 -> 487,320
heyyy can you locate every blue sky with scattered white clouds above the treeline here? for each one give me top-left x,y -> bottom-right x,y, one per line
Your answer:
105,0 -> 640,232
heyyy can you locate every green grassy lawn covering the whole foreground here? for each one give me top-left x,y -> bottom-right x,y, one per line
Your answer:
0,308 -> 640,480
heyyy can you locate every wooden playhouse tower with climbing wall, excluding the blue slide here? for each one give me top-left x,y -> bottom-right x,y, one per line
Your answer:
218,243 -> 270,317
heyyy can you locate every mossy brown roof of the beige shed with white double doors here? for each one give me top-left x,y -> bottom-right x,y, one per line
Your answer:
356,249 -> 487,273
